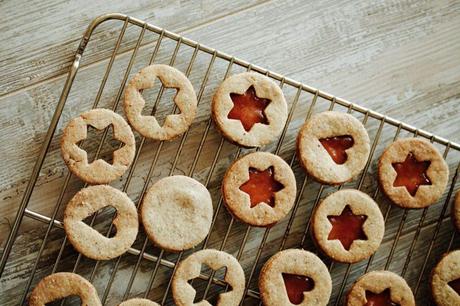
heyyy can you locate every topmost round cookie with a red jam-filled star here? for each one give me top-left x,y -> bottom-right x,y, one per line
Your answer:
212,72 -> 287,147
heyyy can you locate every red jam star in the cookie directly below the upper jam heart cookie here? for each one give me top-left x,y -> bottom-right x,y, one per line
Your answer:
327,205 -> 367,251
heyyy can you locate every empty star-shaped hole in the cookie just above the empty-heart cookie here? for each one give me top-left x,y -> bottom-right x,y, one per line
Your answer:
77,124 -> 124,164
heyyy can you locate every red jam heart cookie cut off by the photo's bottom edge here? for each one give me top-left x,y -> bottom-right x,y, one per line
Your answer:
259,249 -> 332,306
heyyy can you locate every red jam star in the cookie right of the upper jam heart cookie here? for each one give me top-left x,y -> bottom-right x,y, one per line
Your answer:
391,153 -> 431,196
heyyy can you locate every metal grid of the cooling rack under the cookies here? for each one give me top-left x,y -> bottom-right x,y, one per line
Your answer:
0,14 -> 460,305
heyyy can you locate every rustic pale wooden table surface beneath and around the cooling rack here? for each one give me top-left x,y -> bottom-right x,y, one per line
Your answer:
0,0 -> 460,305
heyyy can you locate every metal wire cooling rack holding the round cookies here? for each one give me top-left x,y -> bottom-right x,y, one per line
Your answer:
0,14 -> 460,305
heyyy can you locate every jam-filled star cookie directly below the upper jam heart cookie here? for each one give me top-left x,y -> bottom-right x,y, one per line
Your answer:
312,189 -> 385,263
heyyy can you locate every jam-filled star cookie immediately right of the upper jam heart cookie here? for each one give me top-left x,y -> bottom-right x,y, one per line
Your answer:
378,138 -> 449,208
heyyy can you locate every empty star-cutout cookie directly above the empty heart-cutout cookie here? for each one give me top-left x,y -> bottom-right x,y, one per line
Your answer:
61,108 -> 136,184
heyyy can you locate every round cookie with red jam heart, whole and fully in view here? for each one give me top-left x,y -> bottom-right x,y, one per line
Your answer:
297,111 -> 370,185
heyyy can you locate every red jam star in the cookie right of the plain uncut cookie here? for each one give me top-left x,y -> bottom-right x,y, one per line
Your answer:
240,167 -> 284,208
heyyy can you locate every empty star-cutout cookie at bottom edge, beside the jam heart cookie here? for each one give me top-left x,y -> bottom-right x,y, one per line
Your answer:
172,249 -> 246,306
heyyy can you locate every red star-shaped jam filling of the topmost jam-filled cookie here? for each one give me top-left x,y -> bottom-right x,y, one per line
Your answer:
227,86 -> 271,132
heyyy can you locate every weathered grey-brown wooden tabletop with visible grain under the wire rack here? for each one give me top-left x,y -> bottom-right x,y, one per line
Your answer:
0,1 -> 460,305
